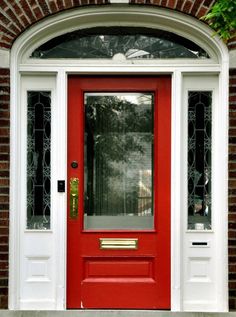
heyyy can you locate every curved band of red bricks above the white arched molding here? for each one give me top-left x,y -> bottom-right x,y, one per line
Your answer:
0,0 -> 218,50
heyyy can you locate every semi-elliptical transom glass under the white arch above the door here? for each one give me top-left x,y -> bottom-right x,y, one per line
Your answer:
30,27 -> 209,59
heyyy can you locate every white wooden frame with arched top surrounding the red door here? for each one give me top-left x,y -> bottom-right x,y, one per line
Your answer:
9,4 -> 229,311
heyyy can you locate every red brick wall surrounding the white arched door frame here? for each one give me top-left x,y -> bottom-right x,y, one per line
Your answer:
0,0 -> 236,310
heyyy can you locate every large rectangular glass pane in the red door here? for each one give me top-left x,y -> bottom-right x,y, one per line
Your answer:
84,93 -> 154,229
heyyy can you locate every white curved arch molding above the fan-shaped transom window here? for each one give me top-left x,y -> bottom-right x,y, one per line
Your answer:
12,5 -> 227,64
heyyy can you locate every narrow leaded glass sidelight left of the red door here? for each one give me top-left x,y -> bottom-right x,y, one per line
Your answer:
27,91 -> 51,229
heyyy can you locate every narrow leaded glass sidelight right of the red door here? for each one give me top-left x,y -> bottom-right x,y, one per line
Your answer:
188,91 -> 212,230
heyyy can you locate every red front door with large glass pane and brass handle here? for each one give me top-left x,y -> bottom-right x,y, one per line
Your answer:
67,76 -> 171,309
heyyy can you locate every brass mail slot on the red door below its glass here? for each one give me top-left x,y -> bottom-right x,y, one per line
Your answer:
99,238 -> 138,250
